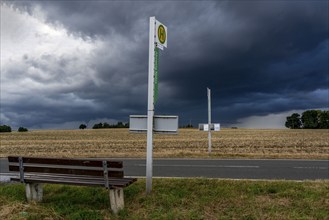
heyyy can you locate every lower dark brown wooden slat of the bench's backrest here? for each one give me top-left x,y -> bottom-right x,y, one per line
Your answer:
9,165 -> 123,178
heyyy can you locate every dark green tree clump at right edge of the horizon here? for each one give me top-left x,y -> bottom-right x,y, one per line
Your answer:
285,110 -> 329,129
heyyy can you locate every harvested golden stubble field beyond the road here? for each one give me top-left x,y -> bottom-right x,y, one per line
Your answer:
0,129 -> 329,159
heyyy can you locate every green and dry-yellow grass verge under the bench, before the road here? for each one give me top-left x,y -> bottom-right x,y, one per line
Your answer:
0,178 -> 329,219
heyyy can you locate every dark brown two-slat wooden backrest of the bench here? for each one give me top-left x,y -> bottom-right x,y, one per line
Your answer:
8,156 -> 124,182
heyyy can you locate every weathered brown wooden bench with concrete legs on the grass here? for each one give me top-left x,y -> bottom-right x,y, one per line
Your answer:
8,156 -> 137,213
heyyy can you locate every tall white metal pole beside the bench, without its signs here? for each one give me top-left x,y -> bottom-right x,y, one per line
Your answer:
146,17 -> 155,193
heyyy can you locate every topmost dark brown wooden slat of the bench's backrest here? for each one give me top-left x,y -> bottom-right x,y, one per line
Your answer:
8,156 -> 123,168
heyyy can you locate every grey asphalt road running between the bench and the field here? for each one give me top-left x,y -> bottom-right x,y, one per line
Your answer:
0,158 -> 329,180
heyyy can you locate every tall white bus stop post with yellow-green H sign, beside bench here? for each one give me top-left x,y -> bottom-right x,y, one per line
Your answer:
146,17 -> 167,193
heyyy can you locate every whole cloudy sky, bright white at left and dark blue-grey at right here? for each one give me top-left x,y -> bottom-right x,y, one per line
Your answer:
0,0 -> 329,129
